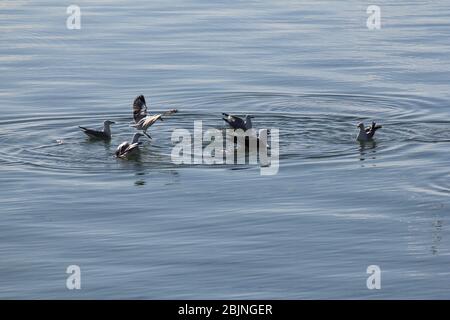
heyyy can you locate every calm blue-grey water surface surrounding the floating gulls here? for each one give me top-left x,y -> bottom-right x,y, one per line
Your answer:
0,0 -> 450,299
